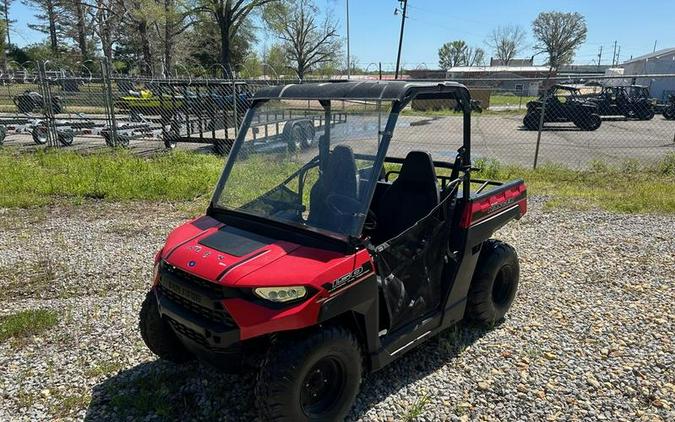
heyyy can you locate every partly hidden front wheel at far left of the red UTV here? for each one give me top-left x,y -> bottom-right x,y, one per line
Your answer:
138,292 -> 194,363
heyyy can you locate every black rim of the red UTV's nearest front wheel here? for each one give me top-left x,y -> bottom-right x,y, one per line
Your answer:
300,357 -> 346,418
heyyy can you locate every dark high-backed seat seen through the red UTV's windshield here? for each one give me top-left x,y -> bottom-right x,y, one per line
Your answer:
307,145 -> 358,231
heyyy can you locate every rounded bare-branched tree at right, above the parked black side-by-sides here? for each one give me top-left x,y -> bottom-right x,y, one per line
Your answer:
532,12 -> 588,69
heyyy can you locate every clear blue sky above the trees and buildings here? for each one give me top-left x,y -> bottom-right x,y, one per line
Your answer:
10,0 -> 675,69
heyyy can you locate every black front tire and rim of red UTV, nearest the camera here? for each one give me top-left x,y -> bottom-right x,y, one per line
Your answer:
255,327 -> 362,421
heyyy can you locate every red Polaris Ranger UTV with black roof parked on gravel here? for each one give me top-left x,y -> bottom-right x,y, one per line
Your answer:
140,81 -> 526,421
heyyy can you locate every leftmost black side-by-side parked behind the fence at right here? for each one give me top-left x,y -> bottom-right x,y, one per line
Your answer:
523,85 -> 602,130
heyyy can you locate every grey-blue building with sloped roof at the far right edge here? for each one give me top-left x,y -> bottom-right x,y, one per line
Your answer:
621,48 -> 675,100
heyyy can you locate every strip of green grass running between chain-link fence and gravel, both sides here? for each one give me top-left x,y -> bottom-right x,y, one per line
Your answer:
0,149 -> 675,213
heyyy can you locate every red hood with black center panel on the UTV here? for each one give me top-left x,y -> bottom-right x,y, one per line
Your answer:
162,217 -> 353,286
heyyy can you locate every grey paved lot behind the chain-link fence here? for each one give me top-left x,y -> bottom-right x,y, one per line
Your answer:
5,114 -> 675,168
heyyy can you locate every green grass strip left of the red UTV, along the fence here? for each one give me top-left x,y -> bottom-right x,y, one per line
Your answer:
0,151 -> 224,207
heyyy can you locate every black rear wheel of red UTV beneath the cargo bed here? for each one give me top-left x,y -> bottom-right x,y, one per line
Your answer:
466,239 -> 520,325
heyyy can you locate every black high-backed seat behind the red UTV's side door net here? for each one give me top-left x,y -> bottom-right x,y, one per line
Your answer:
373,151 -> 440,243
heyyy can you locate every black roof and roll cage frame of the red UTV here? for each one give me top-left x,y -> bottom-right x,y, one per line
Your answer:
208,81 -> 472,245
